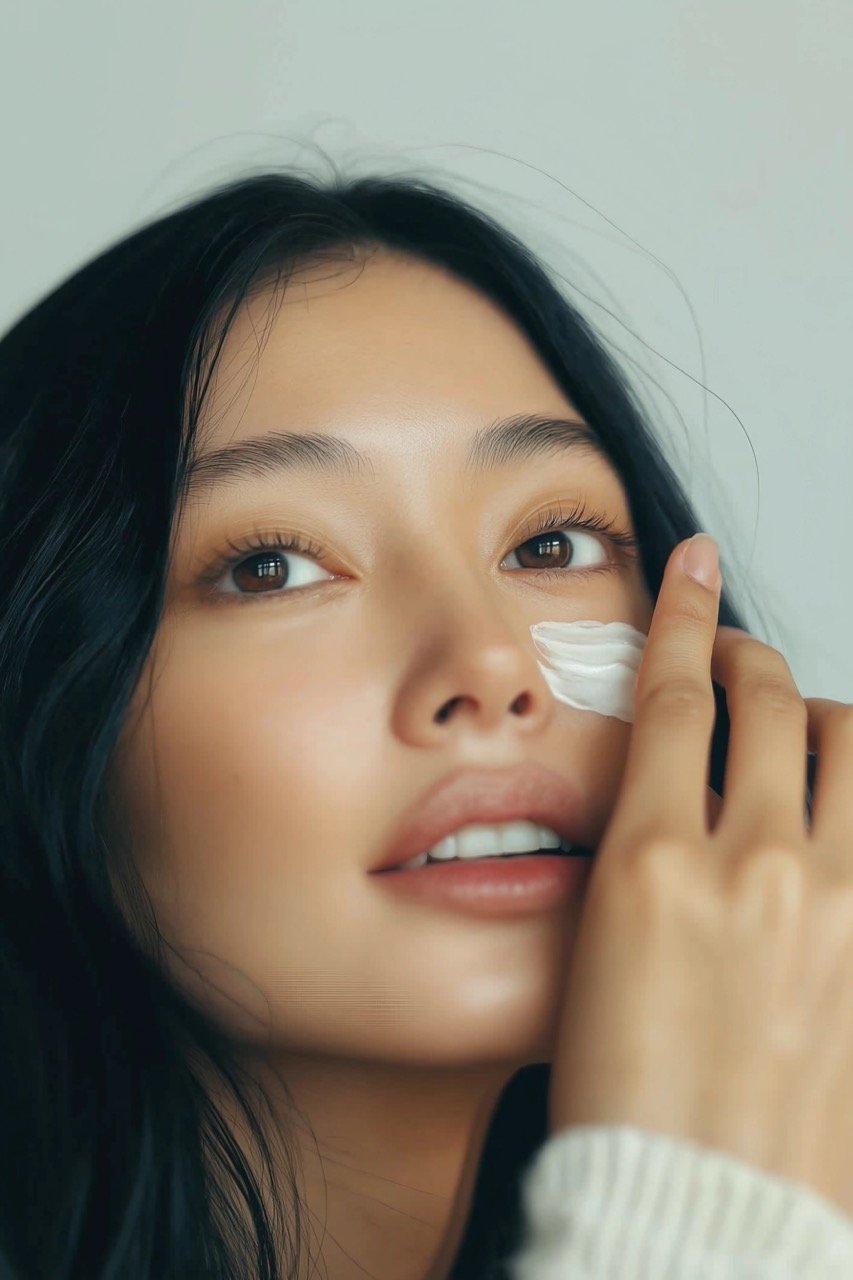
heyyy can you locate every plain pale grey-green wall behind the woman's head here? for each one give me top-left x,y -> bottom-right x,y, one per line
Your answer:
0,0 -> 853,701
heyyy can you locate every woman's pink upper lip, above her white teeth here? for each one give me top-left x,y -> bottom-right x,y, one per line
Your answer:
370,763 -> 593,872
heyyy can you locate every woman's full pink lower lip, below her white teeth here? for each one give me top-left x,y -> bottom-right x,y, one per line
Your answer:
373,854 -> 594,919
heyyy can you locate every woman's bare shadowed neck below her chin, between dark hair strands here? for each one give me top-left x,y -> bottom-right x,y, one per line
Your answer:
206,1053 -> 521,1280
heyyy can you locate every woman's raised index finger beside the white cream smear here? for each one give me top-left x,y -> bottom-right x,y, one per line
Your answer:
604,535 -> 722,840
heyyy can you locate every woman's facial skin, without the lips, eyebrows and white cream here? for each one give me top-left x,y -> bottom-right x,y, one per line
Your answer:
109,251 -> 653,1065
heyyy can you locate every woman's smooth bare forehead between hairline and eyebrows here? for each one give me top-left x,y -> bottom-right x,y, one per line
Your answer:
199,250 -> 578,453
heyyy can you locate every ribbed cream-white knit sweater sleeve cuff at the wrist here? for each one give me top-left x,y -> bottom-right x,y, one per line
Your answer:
506,1125 -> 853,1280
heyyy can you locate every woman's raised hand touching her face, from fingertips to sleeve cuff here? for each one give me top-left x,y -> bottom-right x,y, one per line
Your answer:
548,532 -> 853,1215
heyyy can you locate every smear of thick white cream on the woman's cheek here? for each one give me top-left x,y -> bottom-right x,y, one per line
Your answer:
530,620 -> 647,724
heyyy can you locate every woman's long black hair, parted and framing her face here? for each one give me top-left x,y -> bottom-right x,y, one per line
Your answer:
0,165 -> 778,1280
